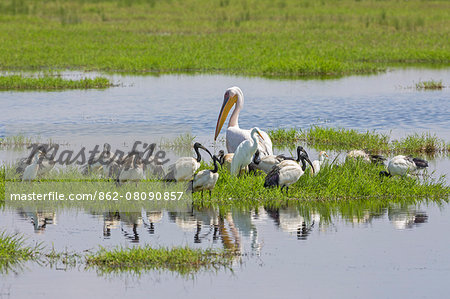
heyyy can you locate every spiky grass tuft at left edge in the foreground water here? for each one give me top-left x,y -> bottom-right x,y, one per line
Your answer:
0,231 -> 39,273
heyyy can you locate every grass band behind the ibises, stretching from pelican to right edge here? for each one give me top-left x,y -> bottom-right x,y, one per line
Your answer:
268,126 -> 450,154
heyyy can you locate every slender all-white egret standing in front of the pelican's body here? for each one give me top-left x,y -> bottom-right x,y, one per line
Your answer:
231,128 -> 264,175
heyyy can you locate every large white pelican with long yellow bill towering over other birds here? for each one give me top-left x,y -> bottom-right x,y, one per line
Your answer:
214,86 -> 273,156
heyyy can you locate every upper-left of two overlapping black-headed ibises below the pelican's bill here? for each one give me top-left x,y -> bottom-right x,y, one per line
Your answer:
164,142 -> 212,182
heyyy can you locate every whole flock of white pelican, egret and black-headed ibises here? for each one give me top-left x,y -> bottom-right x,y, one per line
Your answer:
16,86 -> 428,194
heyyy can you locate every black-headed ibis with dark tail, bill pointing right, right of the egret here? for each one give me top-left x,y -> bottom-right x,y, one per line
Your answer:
264,149 -> 314,195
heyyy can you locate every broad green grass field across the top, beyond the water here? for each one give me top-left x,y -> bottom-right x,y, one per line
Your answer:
0,0 -> 450,77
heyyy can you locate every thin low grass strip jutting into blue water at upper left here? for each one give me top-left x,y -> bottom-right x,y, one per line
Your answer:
0,75 -> 112,90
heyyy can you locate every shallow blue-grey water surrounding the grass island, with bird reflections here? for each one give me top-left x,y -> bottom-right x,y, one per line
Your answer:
0,69 -> 450,298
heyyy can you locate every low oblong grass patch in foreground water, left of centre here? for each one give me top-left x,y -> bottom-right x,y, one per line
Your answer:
86,246 -> 234,275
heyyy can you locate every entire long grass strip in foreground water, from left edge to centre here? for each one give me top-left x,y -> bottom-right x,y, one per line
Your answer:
0,226 -> 236,275
